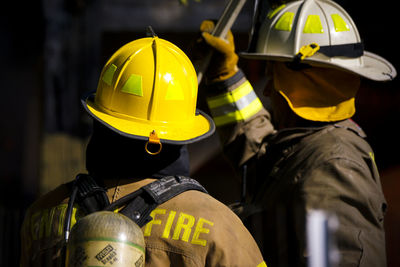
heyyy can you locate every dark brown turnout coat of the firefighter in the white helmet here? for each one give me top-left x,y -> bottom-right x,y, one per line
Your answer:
209,73 -> 387,267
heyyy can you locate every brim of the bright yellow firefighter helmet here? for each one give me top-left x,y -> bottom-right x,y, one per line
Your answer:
81,93 -> 215,145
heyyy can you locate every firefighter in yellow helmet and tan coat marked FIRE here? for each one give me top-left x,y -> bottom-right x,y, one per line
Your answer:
21,29 -> 266,267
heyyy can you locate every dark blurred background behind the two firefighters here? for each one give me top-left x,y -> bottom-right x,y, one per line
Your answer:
0,0 -> 400,267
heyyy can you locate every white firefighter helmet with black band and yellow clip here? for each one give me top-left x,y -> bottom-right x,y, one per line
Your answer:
240,0 -> 396,81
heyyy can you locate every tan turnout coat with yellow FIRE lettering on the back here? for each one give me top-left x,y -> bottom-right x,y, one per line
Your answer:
21,179 -> 266,267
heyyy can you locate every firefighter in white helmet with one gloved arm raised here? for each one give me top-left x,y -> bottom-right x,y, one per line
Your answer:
192,0 -> 396,267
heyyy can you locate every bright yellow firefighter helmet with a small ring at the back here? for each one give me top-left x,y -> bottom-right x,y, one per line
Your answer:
82,36 -> 215,148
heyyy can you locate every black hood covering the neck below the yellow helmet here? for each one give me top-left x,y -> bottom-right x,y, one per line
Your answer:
86,121 -> 189,179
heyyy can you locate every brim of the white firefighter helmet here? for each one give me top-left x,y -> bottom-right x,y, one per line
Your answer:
239,51 -> 397,81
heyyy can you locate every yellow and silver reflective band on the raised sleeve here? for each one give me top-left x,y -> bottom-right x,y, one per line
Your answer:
207,81 -> 262,126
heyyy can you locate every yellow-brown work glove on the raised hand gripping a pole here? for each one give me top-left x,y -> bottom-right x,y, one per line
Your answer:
192,20 -> 239,82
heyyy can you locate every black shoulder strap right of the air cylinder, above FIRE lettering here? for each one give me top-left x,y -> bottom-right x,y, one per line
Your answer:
106,175 -> 208,227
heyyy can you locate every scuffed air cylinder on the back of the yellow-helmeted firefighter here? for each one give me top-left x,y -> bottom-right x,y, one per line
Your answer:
66,211 -> 145,267
